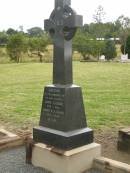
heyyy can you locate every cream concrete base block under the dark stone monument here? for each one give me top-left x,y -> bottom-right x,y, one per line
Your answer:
31,143 -> 101,173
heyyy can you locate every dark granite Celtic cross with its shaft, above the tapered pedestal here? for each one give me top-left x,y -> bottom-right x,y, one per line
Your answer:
44,0 -> 83,85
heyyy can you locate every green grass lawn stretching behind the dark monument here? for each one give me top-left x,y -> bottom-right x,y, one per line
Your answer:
0,62 -> 130,129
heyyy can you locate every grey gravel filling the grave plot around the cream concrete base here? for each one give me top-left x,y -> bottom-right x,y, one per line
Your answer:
0,147 -> 102,173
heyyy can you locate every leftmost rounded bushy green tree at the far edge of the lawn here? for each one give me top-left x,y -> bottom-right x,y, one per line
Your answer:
7,33 -> 27,63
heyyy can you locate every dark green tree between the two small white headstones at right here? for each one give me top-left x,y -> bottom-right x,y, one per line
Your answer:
103,40 -> 117,60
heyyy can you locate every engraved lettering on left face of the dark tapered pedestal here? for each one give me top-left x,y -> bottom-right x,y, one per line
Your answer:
44,88 -> 65,122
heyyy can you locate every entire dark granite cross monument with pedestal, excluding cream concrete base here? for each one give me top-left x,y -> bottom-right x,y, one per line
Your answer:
33,0 -> 93,150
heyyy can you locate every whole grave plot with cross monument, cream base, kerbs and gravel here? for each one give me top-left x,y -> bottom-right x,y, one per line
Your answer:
0,0 -> 130,173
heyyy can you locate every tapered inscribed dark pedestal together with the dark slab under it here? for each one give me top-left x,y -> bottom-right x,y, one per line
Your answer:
33,85 -> 93,150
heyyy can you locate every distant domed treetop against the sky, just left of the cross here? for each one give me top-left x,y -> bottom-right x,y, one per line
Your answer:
27,27 -> 44,37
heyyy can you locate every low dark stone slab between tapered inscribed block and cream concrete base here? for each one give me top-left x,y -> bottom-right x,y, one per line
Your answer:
33,127 -> 93,150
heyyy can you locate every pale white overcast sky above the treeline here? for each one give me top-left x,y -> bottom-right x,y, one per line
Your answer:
0,0 -> 130,31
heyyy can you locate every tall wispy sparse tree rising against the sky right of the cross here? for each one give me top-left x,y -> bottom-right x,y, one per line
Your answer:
93,5 -> 105,23
